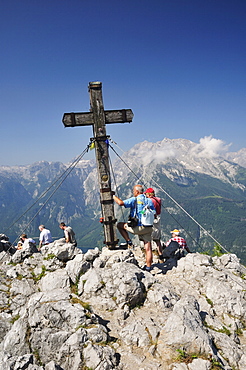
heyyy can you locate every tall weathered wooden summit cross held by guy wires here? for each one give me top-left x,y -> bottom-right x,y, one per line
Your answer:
62,81 -> 133,249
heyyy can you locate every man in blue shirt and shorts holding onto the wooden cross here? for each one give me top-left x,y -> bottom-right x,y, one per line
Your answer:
113,185 -> 155,271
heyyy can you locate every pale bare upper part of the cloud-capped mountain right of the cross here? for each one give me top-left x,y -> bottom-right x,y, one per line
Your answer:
117,137 -> 246,189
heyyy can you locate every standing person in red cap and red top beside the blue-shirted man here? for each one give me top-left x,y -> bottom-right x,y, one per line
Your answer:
144,188 -> 164,262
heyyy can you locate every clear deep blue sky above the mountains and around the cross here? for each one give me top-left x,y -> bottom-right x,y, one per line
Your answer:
0,0 -> 246,165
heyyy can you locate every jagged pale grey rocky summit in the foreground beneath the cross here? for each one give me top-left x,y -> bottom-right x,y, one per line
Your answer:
0,240 -> 246,370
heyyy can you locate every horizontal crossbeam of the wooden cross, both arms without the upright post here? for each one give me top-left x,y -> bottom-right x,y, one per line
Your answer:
62,109 -> 133,127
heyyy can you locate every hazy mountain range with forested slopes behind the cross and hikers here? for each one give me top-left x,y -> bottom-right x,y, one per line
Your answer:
0,138 -> 246,263
